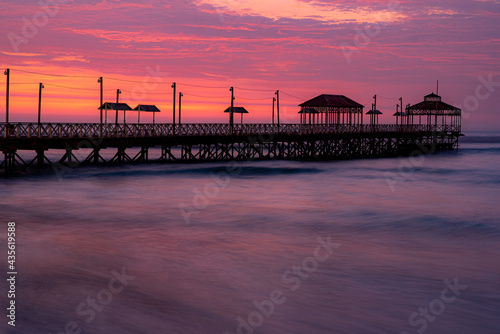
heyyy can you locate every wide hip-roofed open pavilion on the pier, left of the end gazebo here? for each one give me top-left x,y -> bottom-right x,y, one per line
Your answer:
299,94 -> 363,125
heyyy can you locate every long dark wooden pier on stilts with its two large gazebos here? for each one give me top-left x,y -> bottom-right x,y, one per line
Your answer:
0,94 -> 462,173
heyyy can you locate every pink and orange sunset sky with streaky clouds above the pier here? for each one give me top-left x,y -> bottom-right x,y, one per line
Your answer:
0,0 -> 500,130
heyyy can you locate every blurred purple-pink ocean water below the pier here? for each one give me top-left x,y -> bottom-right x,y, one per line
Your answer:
0,133 -> 500,334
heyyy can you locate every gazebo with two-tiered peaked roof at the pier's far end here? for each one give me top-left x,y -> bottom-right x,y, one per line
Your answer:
406,93 -> 462,132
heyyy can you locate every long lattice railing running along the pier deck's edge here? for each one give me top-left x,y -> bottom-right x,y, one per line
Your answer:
0,123 -> 460,138
